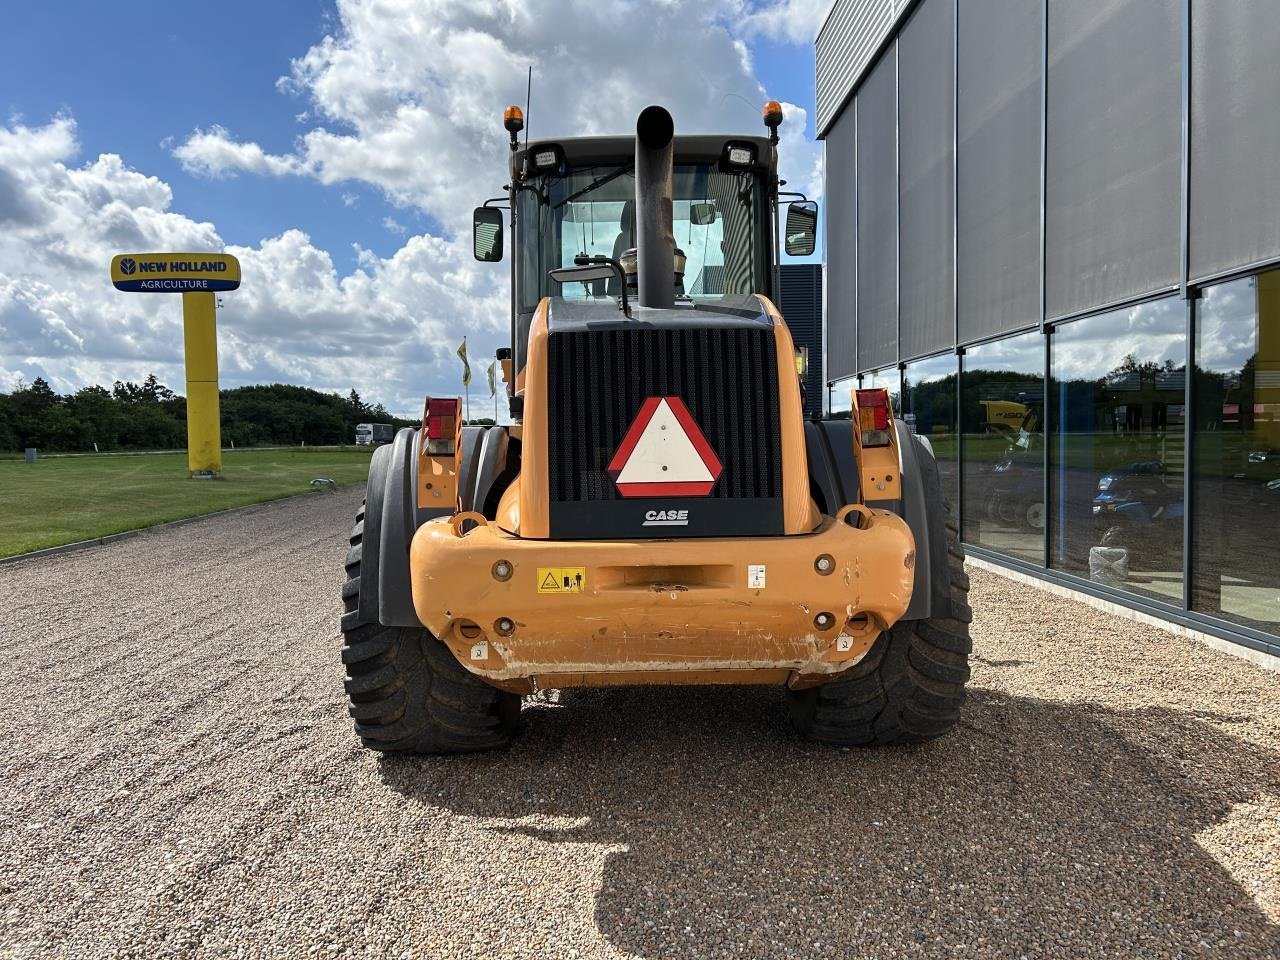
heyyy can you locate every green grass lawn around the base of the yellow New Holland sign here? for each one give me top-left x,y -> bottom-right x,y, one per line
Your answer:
0,448 -> 372,557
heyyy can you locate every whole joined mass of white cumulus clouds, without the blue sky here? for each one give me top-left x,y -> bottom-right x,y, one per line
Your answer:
0,0 -> 822,412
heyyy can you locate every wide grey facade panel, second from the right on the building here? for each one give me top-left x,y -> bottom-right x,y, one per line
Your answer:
1044,0 -> 1183,319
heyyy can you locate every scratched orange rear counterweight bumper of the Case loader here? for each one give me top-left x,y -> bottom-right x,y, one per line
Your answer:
411,507 -> 915,692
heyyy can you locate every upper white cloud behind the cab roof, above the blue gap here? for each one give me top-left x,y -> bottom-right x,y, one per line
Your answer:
175,0 -> 820,220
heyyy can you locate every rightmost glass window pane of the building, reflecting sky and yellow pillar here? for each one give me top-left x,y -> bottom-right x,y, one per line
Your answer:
1192,270 -> 1280,632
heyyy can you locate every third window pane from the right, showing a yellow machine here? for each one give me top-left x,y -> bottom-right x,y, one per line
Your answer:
960,332 -> 1044,563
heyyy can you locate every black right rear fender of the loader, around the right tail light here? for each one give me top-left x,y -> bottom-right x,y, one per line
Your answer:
805,420 -> 951,620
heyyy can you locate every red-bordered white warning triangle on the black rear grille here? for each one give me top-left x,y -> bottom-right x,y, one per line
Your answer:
608,397 -> 723,497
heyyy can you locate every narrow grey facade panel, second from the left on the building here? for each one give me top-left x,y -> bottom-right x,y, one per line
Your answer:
856,50 -> 897,370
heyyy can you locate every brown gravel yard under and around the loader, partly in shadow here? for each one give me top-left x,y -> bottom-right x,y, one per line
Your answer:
0,489 -> 1280,959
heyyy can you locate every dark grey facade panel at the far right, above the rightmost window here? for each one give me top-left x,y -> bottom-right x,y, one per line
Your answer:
1190,0 -> 1280,279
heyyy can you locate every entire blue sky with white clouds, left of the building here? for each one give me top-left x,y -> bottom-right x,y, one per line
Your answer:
0,0 -> 828,416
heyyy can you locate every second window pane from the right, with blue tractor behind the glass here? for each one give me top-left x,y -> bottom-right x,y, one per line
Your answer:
1048,301 -> 1187,604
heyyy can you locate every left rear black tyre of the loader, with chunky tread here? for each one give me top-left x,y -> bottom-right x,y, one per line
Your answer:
342,506 -> 520,754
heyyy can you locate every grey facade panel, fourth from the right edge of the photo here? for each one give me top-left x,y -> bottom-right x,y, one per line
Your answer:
897,0 -> 955,358
